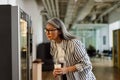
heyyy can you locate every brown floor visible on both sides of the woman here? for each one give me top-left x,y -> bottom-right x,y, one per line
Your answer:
42,58 -> 120,80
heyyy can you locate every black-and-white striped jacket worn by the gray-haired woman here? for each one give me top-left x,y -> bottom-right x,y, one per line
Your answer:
50,39 -> 96,80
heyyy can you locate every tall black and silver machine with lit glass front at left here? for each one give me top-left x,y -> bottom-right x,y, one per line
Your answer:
0,5 -> 32,80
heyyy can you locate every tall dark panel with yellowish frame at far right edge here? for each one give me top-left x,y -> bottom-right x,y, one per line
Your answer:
113,29 -> 120,69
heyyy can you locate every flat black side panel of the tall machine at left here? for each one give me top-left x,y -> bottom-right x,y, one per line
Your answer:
0,5 -> 12,80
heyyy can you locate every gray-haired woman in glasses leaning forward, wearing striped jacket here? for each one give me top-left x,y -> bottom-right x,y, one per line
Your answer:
45,18 -> 96,80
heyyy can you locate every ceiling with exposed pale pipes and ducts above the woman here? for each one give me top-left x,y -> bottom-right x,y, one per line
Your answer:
41,0 -> 120,28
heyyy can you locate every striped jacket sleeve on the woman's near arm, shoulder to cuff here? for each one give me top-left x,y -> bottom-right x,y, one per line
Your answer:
73,39 -> 92,72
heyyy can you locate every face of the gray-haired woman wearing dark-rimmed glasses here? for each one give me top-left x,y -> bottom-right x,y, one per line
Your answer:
45,23 -> 61,41
